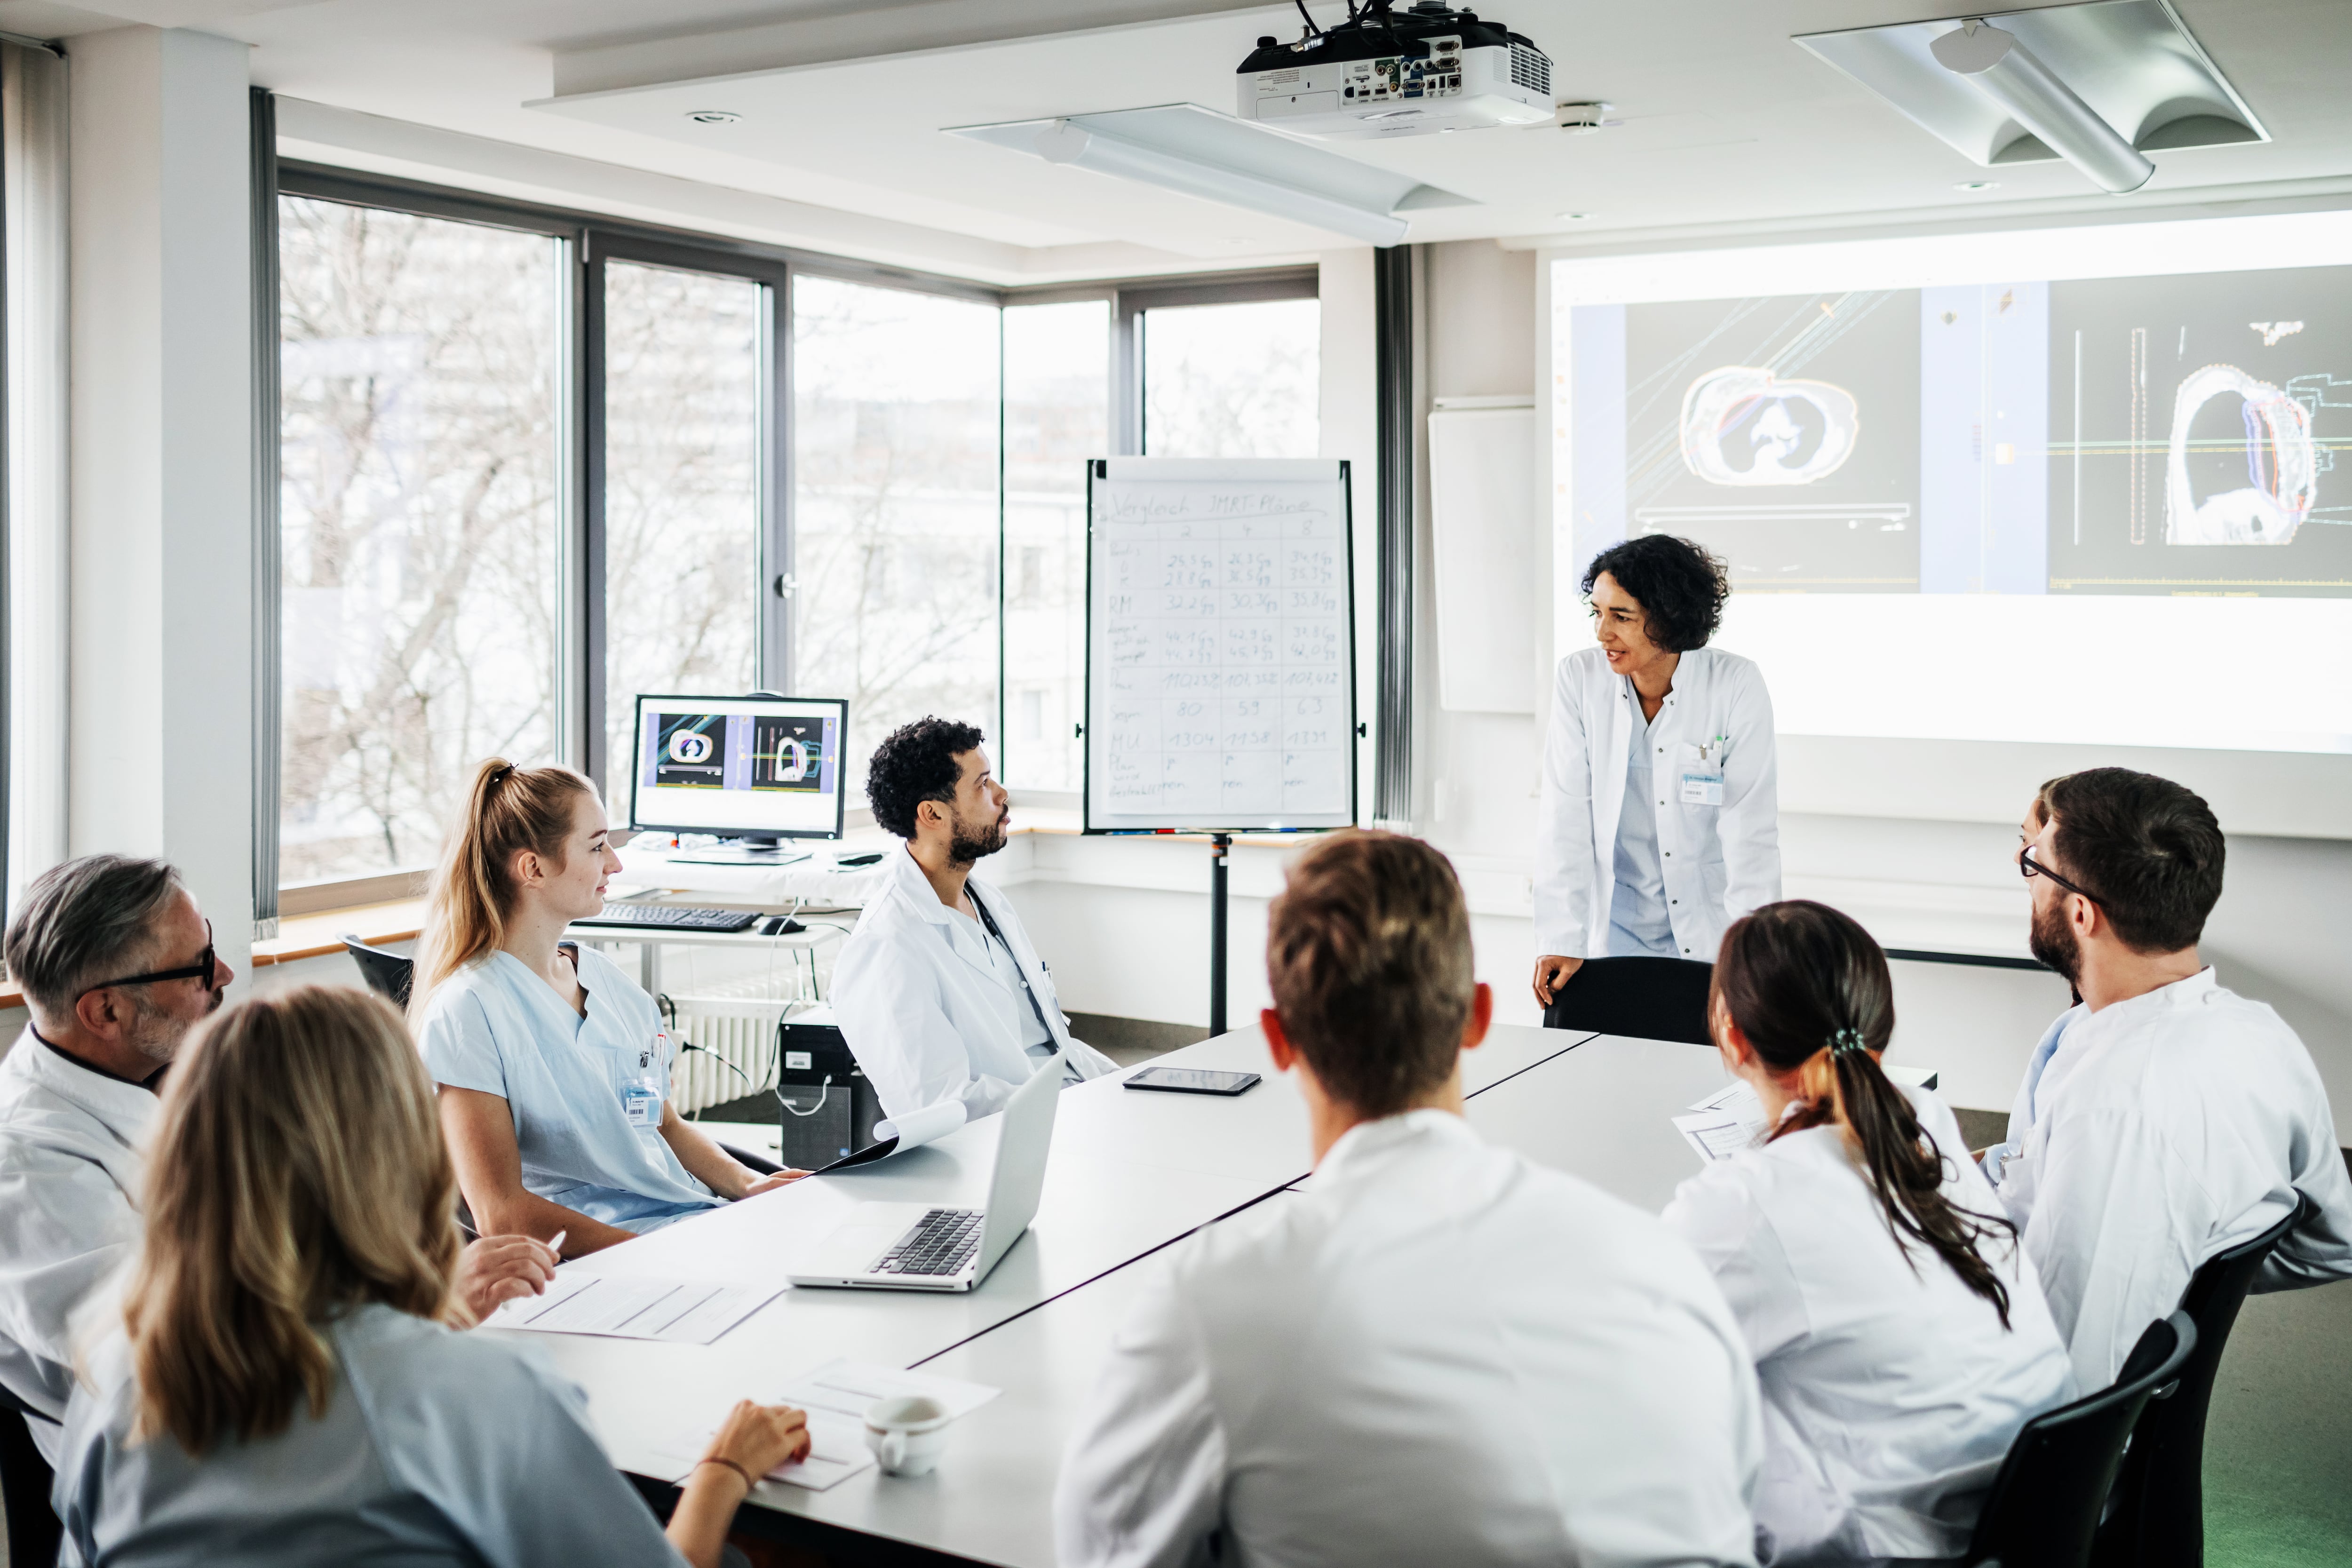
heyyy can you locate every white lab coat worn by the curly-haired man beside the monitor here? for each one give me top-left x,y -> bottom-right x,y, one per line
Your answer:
833,844 -> 1117,1117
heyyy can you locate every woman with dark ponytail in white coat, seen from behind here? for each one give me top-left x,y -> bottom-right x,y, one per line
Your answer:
1665,898 -> 2074,1566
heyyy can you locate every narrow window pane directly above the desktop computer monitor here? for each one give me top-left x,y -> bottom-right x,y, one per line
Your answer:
604,261 -> 760,823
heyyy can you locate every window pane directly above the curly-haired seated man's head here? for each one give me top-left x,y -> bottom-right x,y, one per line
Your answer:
793,278 -> 1000,792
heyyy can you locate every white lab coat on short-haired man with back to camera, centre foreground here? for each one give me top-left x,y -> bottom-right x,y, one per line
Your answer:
1054,1110 -> 1762,1568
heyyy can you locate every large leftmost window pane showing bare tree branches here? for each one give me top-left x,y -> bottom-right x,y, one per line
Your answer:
280,198 -> 562,882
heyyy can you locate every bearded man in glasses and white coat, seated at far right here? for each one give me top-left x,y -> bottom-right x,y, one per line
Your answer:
1985,769 -> 2352,1389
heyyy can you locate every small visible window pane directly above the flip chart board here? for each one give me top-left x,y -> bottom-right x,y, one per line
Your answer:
1138,299 -> 1322,458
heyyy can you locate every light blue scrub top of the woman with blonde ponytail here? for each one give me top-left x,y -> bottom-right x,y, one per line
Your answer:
416,947 -> 720,1232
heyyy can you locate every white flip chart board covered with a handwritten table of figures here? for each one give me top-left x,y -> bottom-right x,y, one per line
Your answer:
1084,458 -> 1355,832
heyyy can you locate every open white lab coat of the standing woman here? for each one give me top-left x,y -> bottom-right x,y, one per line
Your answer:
1534,646 -> 1780,964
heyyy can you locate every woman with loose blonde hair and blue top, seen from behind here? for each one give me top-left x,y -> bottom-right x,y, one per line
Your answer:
56,985 -> 809,1568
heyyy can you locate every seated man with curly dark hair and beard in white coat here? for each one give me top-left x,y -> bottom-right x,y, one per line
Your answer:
833,719 -> 1117,1122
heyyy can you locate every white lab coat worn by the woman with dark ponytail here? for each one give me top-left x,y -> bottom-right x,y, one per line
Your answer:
1663,1089 -> 2074,1563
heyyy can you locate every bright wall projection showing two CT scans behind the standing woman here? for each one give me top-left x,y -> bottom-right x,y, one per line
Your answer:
1548,212 -> 2352,762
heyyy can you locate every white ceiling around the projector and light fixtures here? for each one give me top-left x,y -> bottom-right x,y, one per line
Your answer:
0,0 -> 2352,282
